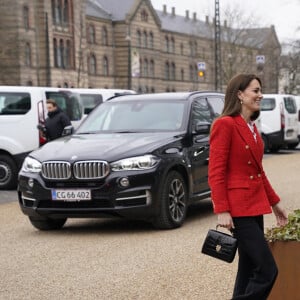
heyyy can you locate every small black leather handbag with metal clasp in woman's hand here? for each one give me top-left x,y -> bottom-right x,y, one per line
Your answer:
201,225 -> 237,263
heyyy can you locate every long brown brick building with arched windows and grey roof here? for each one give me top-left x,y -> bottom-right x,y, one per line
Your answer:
0,0 -> 280,93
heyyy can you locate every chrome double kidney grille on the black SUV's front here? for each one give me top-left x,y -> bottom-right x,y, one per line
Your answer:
42,160 -> 109,180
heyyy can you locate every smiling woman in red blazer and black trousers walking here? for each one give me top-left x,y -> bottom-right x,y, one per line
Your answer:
209,74 -> 287,300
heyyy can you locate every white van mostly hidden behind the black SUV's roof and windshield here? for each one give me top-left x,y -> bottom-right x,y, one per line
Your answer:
69,88 -> 136,116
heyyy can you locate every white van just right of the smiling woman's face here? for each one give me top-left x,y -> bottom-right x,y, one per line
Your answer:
260,94 -> 299,152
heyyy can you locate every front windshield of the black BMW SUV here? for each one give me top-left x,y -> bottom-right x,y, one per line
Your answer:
77,100 -> 186,133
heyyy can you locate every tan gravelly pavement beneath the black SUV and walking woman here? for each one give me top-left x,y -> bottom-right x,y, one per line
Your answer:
0,152 -> 300,300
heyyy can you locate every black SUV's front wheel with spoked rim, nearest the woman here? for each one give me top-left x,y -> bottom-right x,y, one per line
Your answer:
153,171 -> 188,229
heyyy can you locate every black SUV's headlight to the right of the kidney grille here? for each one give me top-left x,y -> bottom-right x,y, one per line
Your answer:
111,155 -> 159,171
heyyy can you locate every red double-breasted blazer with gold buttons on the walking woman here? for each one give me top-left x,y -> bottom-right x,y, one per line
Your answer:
208,116 -> 280,217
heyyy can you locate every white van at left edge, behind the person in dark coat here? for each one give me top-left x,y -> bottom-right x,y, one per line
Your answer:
0,86 -> 83,189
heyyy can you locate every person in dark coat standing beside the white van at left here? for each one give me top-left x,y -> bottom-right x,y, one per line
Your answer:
45,99 -> 71,141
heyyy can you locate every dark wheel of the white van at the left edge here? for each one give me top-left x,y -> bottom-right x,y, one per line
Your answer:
0,154 -> 18,190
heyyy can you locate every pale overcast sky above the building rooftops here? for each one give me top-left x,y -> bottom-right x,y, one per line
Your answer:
151,0 -> 300,42
